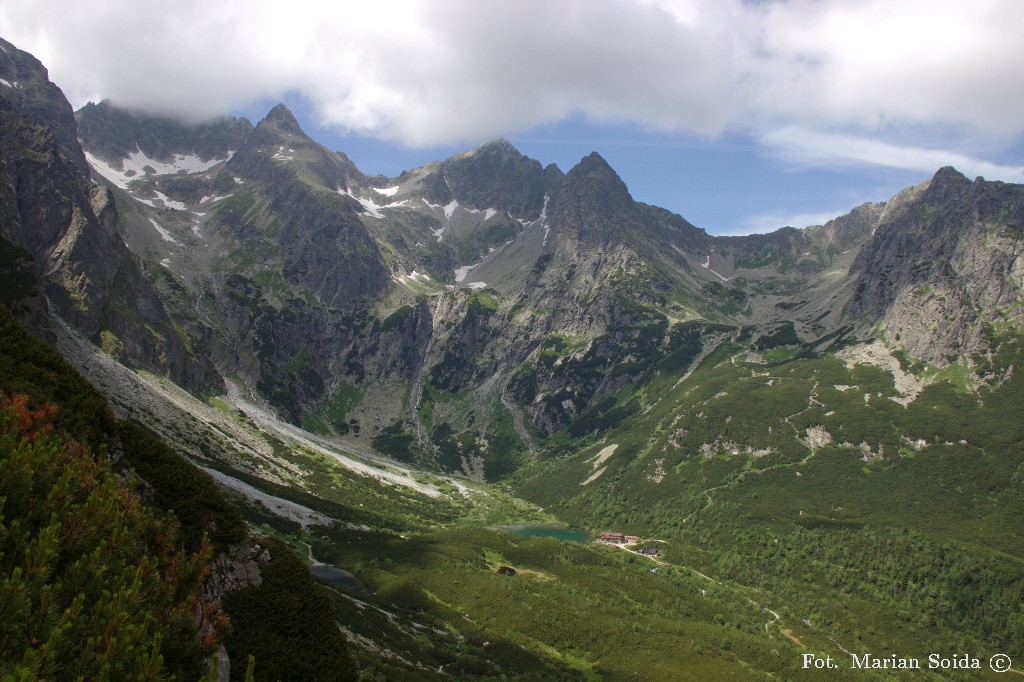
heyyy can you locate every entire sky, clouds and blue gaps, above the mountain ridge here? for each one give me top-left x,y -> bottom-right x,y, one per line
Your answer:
0,0 -> 1024,233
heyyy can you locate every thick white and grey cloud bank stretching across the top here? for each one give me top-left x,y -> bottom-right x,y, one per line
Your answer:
0,0 -> 1024,152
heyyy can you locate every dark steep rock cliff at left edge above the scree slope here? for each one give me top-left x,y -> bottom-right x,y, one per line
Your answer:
0,41 -> 212,389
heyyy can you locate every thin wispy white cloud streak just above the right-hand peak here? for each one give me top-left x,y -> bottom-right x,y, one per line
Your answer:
762,126 -> 1024,182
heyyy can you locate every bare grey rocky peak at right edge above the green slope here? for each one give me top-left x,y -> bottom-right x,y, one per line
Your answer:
849,168 -> 1024,366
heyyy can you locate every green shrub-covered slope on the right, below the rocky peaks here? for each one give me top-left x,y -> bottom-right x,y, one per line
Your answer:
514,329 -> 1024,658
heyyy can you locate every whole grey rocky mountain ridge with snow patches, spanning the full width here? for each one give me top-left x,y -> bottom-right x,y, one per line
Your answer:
0,35 -> 1024,478
